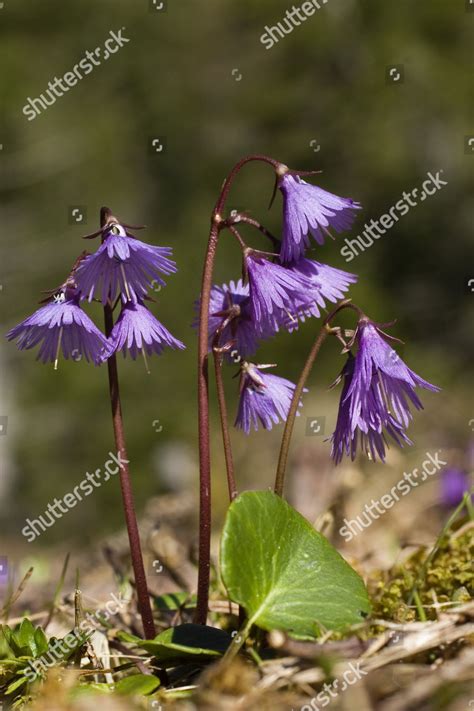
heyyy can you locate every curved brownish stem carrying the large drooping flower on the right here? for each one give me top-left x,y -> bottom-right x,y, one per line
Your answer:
274,299 -> 359,496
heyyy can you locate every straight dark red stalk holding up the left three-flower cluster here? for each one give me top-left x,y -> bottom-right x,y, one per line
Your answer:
101,209 -> 156,639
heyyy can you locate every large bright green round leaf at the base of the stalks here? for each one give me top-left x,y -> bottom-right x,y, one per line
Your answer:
221,491 -> 370,637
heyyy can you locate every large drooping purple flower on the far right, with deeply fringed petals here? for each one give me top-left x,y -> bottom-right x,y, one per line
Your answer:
331,317 -> 439,463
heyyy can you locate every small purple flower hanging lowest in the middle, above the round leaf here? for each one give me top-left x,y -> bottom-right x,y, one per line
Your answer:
234,363 -> 306,434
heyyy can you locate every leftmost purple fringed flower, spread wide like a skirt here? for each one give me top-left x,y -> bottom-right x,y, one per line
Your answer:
7,287 -> 107,368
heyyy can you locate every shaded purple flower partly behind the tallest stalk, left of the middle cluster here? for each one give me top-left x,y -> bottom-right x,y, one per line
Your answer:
193,279 -> 258,357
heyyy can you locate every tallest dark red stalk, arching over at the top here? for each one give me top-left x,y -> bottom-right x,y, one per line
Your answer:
194,154 -> 280,625
